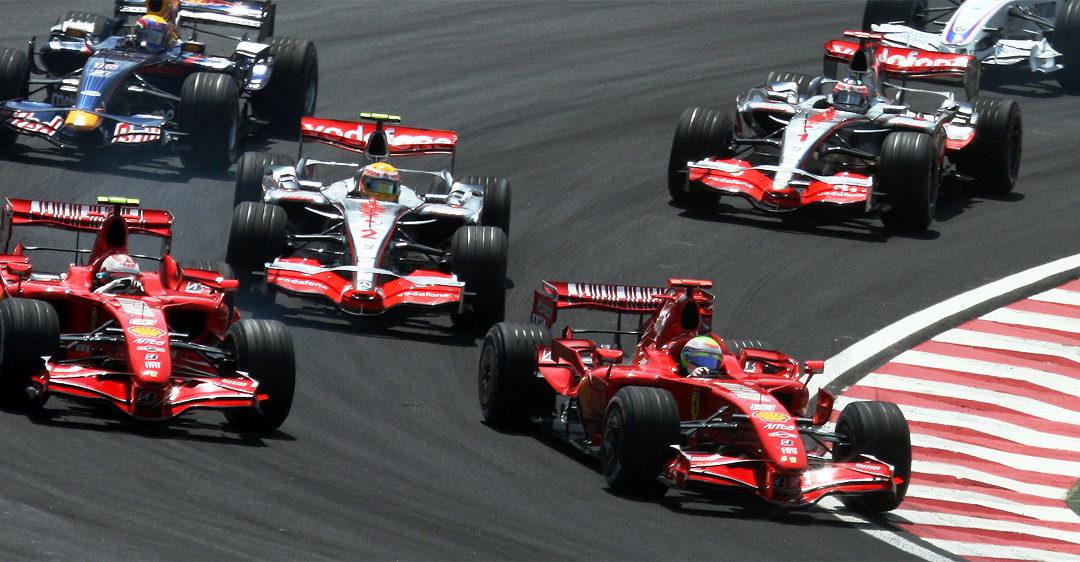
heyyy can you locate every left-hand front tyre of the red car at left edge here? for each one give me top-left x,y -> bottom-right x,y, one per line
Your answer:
0,297 -> 60,410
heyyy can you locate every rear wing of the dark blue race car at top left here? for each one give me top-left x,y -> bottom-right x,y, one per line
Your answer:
113,0 -> 278,40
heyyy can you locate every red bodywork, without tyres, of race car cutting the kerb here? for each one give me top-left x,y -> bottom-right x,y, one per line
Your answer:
532,280 -> 902,506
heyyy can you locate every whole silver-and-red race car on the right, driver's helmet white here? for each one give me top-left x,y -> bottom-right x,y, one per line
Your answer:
667,31 -> 1022,232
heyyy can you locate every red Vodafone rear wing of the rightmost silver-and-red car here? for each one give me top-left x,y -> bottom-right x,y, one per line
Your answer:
825,31 -> 982,99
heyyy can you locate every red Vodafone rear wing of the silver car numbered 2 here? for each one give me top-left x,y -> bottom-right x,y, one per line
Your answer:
300,116 -> 458,159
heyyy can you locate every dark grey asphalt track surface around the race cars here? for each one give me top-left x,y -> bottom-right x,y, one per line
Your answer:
0,0 -> 1080,560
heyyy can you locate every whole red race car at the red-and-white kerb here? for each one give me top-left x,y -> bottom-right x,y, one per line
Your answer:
480,279 -> 912,512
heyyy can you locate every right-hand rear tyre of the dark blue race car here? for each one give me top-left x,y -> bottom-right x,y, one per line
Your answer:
252,37 -> 319,137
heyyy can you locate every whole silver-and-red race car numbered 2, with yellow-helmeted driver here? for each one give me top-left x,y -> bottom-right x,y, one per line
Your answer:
227,113 -> 510,330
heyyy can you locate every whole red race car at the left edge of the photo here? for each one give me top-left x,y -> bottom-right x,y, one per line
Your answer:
0,198 -> 296,431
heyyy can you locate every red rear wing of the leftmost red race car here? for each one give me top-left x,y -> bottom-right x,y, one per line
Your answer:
0,198 -> 173,253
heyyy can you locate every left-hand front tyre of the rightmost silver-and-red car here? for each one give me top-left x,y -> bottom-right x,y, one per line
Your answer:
667,107 -> 734,208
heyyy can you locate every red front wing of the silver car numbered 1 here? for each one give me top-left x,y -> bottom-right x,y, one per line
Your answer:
687,159 -> 873,211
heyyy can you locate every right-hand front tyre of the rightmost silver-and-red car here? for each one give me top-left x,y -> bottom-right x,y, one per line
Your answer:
877,131 -> 937,233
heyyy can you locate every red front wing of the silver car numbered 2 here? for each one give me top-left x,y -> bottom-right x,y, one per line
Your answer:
267,257 -> 464,315
